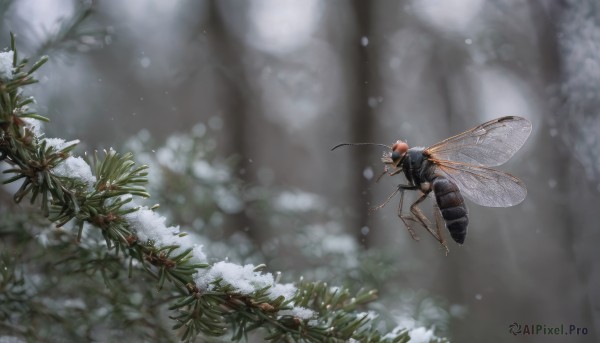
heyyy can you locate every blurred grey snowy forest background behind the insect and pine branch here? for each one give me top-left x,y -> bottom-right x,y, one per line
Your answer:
0,0 -> 600,342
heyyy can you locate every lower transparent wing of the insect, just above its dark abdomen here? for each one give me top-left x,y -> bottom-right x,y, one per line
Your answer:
431,159 -> 527,207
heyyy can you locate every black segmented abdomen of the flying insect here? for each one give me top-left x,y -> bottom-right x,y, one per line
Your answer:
432,177 -> 469,244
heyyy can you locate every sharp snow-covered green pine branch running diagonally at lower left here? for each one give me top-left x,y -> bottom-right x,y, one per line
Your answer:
0,35 -> 442,342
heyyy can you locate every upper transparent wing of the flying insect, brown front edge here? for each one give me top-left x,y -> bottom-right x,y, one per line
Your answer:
425,116 -> 531,167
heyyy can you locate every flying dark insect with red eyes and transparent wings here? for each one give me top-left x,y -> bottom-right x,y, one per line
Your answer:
331,116 -> 531,253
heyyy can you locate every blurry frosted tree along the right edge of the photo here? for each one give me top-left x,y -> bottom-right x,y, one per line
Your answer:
546,1 -> 600,337
